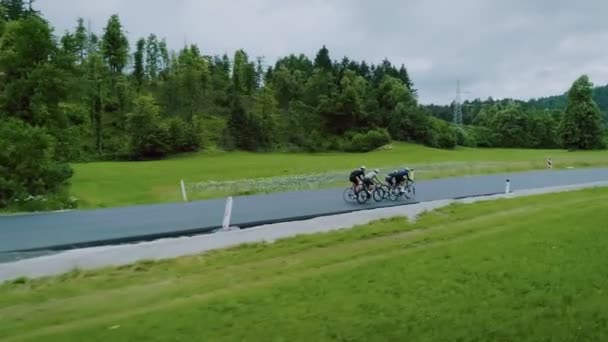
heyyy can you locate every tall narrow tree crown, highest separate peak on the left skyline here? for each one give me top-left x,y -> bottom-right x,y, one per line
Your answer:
101,14 -> 129,73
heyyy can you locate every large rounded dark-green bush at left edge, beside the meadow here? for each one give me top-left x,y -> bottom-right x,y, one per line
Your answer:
0,119 -> 73,207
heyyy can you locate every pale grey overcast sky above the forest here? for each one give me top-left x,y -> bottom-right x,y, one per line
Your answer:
36,0 -> 608,103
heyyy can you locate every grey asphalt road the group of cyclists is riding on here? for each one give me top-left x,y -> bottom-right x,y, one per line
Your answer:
0,169 -> 608,254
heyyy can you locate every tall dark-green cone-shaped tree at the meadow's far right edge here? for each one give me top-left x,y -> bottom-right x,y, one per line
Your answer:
560,75 -> 602,150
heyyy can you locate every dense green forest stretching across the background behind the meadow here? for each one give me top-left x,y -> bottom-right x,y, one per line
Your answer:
0,0 -> 607,207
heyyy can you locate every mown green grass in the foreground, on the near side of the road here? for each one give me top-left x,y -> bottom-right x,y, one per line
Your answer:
0,189 -> 608,342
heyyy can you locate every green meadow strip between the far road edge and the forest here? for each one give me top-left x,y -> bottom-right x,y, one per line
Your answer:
72,143 -> 608,208
